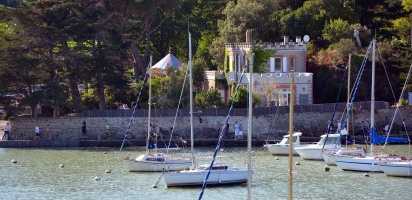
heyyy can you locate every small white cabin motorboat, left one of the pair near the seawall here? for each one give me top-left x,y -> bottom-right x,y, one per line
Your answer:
263,132 -> 302,156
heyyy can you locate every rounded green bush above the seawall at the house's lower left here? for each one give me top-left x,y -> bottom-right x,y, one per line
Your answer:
195,89 -> 224,108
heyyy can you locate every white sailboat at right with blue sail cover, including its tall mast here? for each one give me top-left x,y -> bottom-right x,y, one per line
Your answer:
332,39 -> 401,172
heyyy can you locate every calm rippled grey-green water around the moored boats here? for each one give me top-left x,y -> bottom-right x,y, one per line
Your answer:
0,145 -> 412,200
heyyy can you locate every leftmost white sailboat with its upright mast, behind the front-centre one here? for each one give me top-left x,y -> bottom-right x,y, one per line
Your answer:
125,56 -> 192,172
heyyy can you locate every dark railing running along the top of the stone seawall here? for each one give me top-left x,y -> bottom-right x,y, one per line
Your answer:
82,101 -> 388,117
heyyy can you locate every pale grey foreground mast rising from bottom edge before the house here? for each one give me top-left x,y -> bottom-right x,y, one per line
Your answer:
247,53 -> 255,200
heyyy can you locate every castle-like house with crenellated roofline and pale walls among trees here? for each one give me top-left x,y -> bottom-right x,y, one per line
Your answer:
205,32 -> 313,106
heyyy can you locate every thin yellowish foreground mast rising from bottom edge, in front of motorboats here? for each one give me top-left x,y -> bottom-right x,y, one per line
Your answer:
289,70 -> 295,200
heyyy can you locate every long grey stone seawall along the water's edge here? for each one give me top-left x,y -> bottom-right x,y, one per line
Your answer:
4,108 -> 412,145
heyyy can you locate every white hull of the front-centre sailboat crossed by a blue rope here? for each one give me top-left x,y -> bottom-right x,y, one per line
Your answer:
163,168 -> 248,187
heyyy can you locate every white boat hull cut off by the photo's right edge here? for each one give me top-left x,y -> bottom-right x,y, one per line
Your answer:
380,161 -> 412,177
